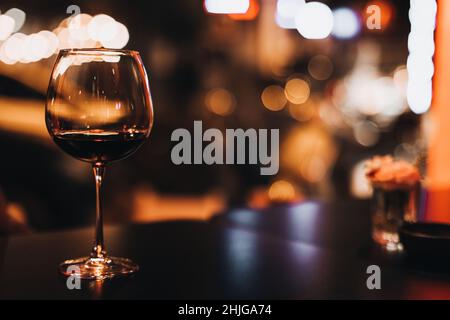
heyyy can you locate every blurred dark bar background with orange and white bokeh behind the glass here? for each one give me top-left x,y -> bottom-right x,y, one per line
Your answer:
0,0 -> 428,232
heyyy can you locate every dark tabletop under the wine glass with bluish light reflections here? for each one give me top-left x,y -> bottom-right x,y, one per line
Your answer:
0,202 -> 450,299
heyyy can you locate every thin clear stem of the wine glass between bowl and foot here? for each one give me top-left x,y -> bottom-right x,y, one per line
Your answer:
91,163 -> 106,259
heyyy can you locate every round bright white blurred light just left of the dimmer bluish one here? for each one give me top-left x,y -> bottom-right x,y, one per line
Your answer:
295,2 -> 333,39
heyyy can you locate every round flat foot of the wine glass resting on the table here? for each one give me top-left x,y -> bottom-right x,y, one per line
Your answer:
59,257 -> 139,280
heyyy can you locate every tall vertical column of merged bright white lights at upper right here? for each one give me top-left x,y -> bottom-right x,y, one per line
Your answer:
406,0 -> 437,114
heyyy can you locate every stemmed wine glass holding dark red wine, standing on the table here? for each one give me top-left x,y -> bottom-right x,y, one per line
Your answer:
45,49 -> 153,279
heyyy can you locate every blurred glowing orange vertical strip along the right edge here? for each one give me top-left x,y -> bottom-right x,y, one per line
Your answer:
425,0 -> 450,223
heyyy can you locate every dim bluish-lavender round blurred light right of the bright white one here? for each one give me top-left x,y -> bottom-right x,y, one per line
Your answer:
332,8 -> 361,39
